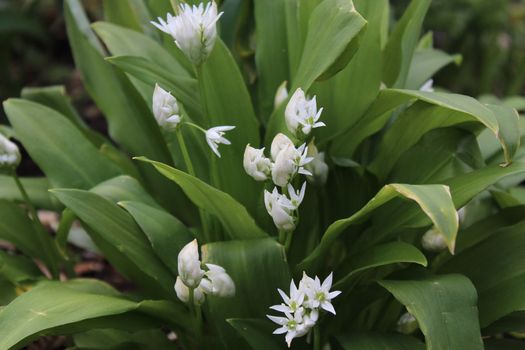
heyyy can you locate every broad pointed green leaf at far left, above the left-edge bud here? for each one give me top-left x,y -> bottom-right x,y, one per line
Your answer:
4,99 -> 120,188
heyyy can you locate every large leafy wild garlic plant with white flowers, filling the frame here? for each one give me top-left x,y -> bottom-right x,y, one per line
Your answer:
0,0 -> 525,350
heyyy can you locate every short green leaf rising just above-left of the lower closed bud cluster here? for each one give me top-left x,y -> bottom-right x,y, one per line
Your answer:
118,201 -> 193,275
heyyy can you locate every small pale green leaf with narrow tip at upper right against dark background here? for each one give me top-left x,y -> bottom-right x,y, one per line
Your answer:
405,49 -> 461,90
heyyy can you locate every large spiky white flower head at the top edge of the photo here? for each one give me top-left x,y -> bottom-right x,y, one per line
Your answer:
151,1 -> 222,65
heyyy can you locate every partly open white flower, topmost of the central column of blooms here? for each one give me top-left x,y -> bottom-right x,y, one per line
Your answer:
284,88 -> 325,139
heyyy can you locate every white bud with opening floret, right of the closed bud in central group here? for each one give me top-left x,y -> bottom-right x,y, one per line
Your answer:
272,144 -> 312,187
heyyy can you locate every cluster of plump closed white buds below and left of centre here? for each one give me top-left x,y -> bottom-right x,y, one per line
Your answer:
175,239 -> 235,305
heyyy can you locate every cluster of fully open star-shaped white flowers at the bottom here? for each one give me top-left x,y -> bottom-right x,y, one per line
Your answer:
266,272 -> 341,347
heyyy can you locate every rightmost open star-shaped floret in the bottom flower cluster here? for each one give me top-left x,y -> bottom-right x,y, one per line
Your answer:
299,273 -> 341,315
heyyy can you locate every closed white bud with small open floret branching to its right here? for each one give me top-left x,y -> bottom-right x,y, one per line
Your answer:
152,84 -> 235,158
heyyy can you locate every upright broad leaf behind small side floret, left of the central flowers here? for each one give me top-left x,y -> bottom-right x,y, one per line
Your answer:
199,40 -> 261,213
